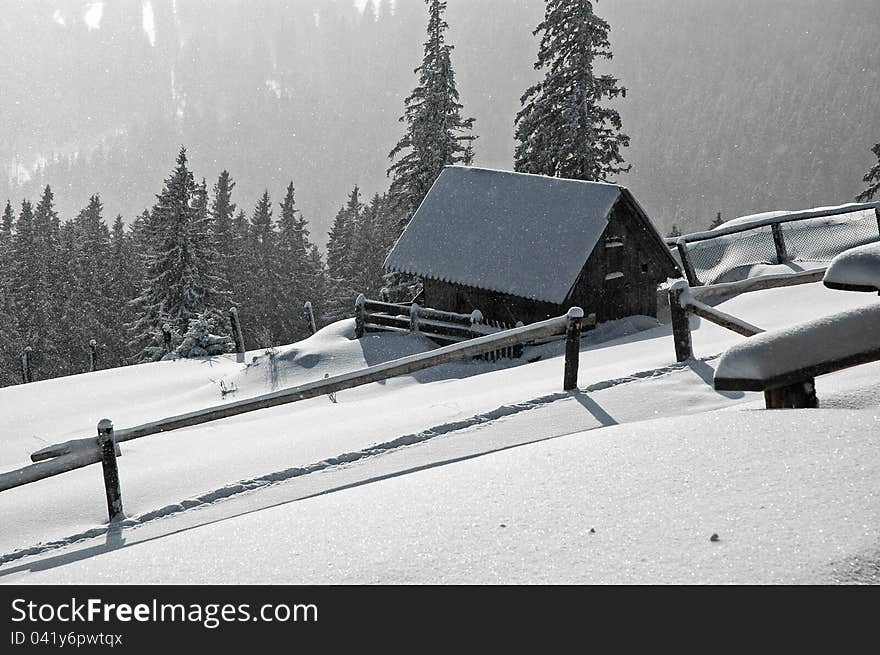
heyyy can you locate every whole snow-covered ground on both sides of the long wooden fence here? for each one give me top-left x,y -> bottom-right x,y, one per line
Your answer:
0,284 -> 880,584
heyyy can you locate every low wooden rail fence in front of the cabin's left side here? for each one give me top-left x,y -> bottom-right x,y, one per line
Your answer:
355,294 -> 522,361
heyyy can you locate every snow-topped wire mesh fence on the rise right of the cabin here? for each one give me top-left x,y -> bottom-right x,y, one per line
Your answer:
666,202 -> 880,287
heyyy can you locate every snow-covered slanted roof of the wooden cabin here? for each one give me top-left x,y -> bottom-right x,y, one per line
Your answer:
385,166 -> 665,304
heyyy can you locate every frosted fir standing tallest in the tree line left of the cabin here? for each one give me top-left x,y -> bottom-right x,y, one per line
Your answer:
131,148 -> 229,361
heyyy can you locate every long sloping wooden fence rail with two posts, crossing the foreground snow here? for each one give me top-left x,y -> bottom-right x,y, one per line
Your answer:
0,307 -> 596,520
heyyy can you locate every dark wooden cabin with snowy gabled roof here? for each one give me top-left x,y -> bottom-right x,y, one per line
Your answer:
385,166 -> 681,324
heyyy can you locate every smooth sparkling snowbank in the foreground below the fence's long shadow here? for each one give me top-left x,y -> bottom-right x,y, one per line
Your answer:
5,410 -> 880,584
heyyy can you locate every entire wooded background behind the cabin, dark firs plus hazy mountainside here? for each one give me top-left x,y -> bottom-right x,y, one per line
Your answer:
0,0 -> 880,385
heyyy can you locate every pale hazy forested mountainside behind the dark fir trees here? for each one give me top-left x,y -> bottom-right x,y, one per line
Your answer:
0,0 -> 880,236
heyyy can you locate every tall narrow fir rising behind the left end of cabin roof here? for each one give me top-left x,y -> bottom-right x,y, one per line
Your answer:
388,0 -> 476,224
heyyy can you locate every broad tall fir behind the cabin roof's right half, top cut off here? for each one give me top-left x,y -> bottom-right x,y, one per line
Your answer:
514,0 -> 630,180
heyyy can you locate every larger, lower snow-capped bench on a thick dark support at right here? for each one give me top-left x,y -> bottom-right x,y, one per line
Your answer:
715,304 -> 880,409
